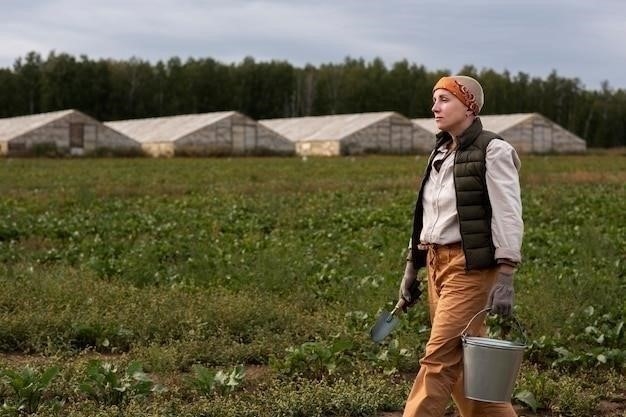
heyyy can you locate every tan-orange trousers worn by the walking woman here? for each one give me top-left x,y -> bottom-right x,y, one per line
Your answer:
403,244 -> 517,417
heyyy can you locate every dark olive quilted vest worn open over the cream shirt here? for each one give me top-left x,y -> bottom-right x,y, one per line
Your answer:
411,118 -> 498,270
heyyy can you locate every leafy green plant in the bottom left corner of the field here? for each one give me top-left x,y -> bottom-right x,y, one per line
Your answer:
0,366 -> 59,414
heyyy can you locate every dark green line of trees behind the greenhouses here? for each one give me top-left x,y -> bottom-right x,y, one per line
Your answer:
0,51 -> 626,147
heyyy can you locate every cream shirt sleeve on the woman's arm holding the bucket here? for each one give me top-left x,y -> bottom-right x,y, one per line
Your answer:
486,139 -> 524,264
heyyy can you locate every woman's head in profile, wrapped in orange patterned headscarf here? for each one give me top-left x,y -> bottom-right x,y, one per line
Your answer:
432,75 -> 485,136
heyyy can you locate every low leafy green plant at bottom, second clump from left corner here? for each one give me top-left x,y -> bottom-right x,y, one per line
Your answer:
78,360 -> 164,405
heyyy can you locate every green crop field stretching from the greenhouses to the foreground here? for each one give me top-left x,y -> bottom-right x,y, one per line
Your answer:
0,154 -> 626,417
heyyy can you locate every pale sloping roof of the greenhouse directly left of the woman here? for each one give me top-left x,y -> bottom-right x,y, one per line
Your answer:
259,112 -> 403,142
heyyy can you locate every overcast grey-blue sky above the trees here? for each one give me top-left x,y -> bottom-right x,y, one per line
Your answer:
0,0 -> 626,89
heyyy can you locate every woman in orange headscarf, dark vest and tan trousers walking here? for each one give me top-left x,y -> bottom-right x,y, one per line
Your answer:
400,76 -> 523,417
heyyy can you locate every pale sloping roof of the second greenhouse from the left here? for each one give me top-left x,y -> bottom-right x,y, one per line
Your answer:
104,111 -> 237,143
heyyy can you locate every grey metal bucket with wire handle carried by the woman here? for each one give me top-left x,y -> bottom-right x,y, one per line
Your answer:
461,309 -> 526,403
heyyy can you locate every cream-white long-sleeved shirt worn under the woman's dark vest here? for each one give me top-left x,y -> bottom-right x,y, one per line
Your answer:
420,139 -> 524,263
